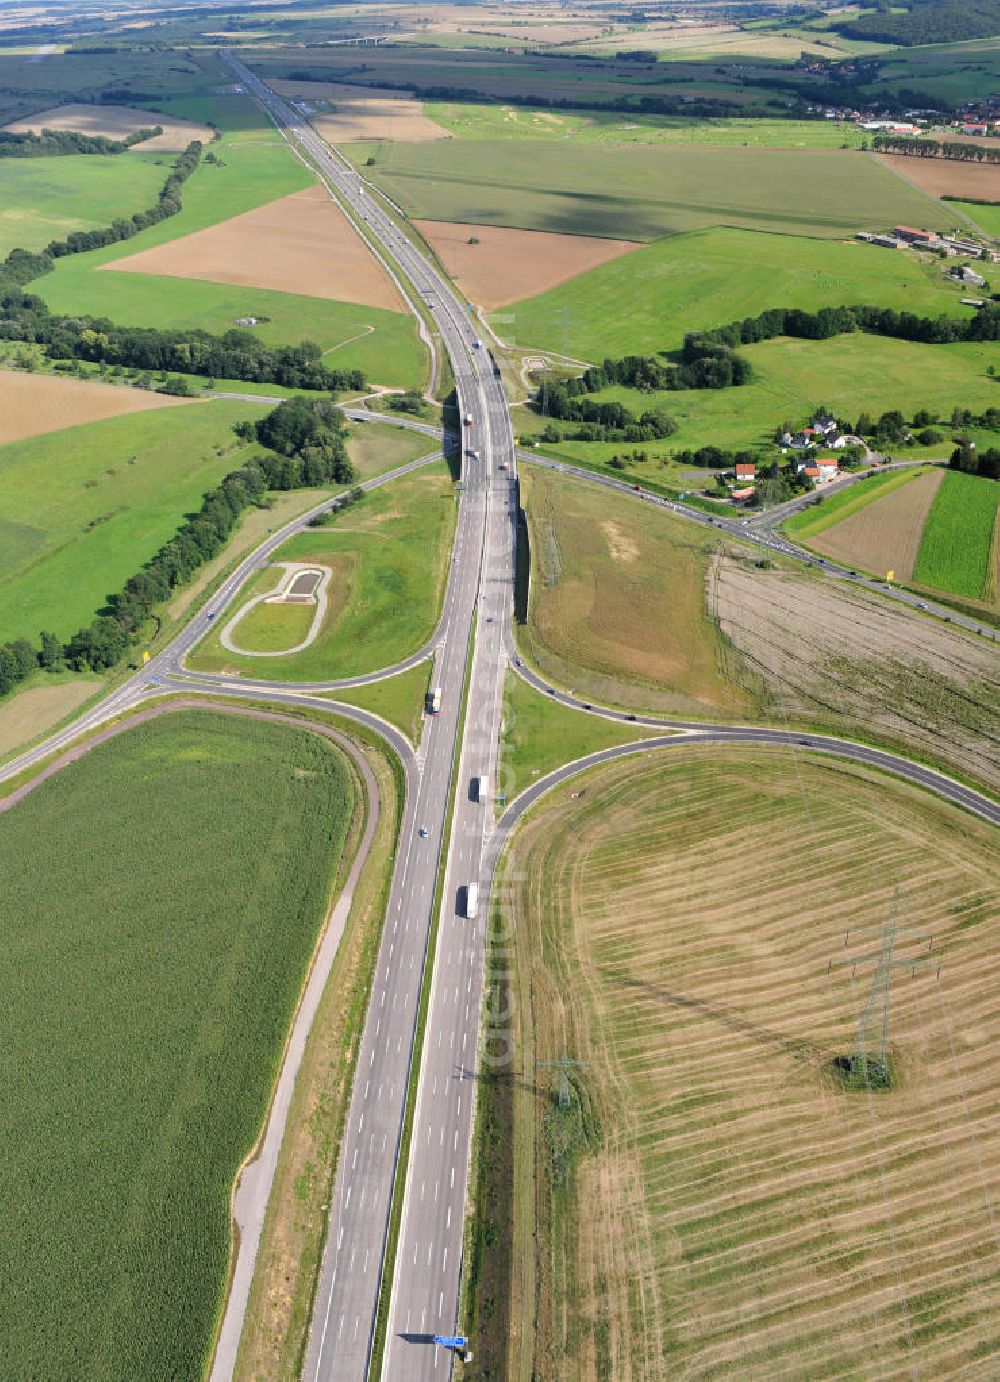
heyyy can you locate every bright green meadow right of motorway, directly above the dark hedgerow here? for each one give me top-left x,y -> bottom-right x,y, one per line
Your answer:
496,225 -> 968,361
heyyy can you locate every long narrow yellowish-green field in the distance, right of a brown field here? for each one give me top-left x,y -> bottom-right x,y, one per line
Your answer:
424,101 -> 862,149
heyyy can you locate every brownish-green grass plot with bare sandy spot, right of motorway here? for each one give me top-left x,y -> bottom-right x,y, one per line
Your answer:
518,468 -> 751,719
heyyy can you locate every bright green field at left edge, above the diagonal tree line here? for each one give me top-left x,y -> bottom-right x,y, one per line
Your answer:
0,390 -> 267,641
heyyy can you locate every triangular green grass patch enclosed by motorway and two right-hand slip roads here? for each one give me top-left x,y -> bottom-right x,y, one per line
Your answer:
496,672 -> 652,814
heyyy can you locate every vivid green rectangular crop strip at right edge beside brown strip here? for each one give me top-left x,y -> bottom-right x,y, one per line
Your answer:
913,470 -> 1000,600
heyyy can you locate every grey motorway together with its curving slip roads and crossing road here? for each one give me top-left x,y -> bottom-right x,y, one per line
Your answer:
0,54 -> 1000,1382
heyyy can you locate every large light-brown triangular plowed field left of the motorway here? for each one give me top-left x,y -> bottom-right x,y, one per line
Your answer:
102,187 -> 403,312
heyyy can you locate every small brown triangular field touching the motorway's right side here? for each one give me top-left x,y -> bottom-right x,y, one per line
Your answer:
414,221 -> 642,311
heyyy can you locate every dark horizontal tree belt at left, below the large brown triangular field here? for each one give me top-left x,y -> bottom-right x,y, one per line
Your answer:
0,287 -> 365,391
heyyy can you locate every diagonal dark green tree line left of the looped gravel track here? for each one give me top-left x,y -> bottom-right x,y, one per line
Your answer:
0,398 -> 356,697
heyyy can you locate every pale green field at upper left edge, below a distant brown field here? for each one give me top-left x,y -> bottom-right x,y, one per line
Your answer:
0,152 -> 167,258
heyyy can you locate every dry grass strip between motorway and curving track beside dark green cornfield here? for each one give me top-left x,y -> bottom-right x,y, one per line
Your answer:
235,712 -> 403,1382
